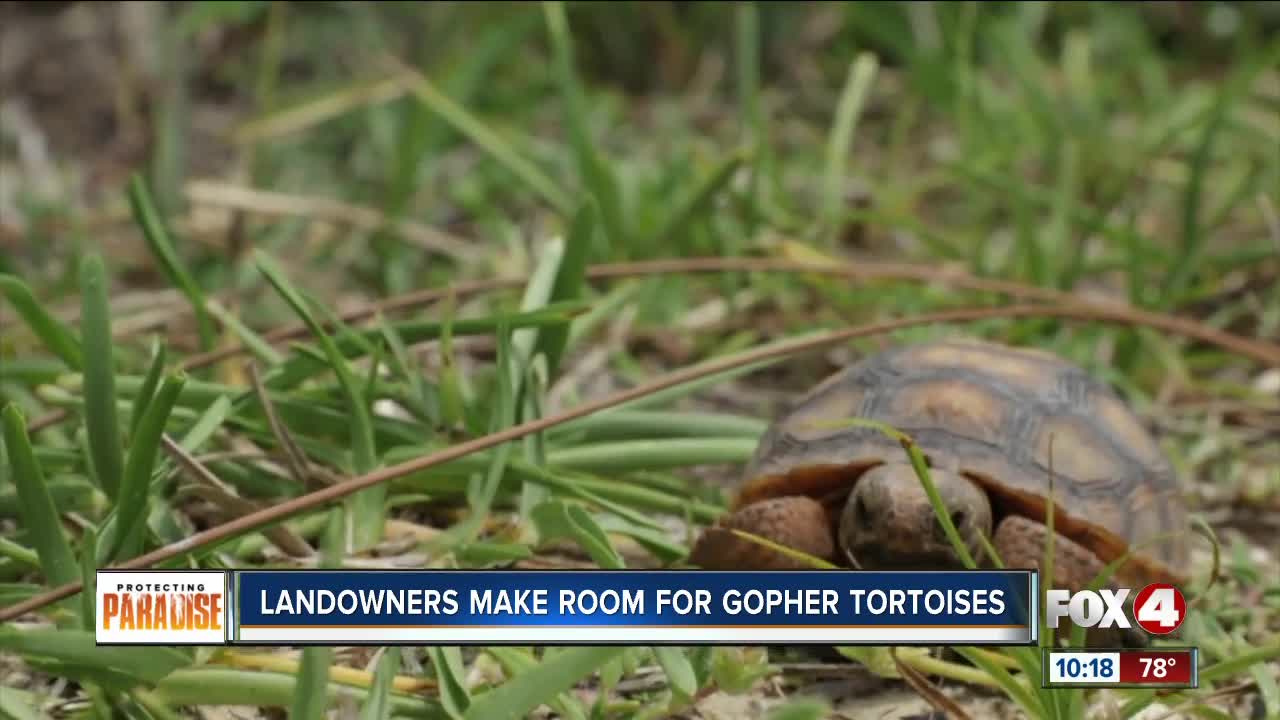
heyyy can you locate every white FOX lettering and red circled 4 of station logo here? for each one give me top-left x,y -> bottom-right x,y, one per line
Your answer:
1044,583 -> 1187,635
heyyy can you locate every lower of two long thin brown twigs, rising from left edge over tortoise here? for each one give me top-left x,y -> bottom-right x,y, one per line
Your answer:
0,299 -> 1269,623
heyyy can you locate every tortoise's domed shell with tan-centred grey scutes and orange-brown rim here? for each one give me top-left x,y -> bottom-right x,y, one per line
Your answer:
736,340 -> 1188,582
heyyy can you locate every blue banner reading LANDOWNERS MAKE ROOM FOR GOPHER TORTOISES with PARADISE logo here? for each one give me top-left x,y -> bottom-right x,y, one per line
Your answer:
96,570 -> 1039,646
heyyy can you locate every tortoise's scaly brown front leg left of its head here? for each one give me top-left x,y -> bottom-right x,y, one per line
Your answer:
689,496 -> 836,570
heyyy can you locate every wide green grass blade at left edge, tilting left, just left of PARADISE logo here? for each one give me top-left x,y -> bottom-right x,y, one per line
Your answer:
3,405 -> 79,585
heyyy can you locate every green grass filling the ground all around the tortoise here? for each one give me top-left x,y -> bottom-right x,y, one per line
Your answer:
0,3 -> 1280,720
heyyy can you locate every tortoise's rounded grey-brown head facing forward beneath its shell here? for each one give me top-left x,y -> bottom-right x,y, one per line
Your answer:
840,462 -> 992,570
